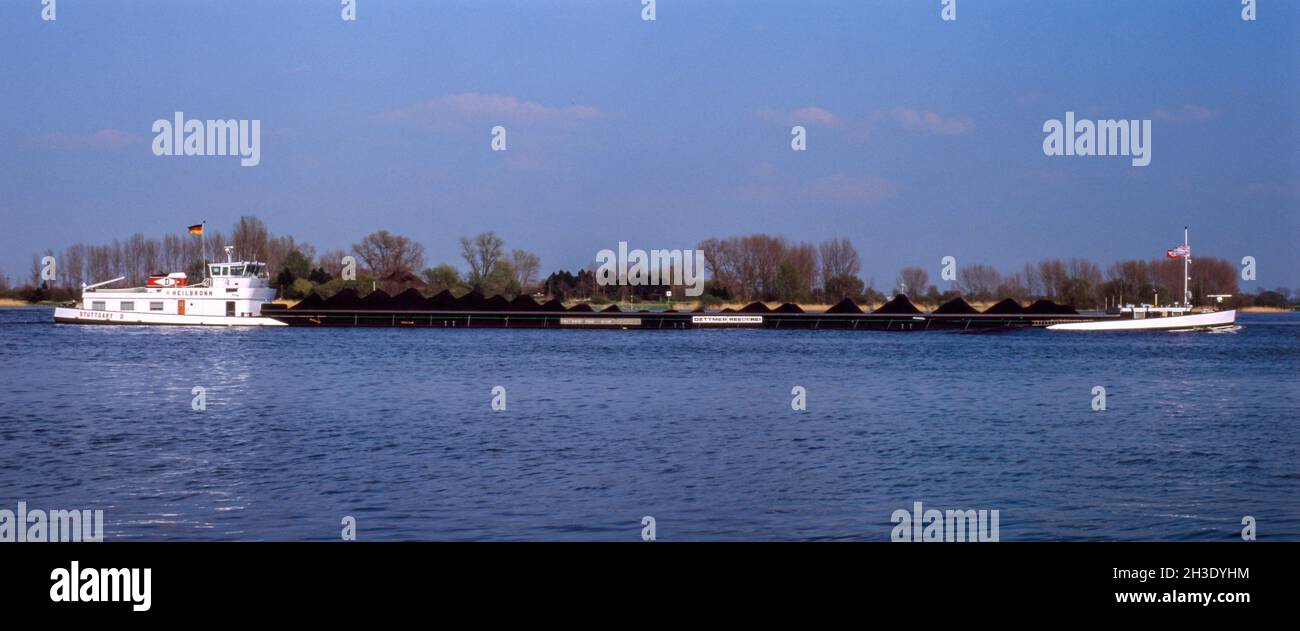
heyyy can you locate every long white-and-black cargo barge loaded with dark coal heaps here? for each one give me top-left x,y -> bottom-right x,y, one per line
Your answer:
55,226 -> 1236,332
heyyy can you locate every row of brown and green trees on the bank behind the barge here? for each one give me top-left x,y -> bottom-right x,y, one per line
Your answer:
0,221 -> 1295,308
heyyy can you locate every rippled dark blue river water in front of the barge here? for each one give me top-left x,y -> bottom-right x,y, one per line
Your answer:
0,310 -> 1300,541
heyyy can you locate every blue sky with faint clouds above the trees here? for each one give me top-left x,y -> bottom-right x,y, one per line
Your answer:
0,0 -> 1300,290
